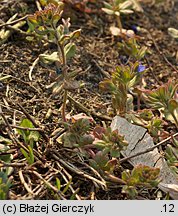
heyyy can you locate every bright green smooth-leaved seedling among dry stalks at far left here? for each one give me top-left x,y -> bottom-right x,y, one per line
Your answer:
17,119 -> 40,165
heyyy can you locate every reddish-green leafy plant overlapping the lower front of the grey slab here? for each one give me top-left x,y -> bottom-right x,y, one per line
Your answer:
122,165 -> 160,199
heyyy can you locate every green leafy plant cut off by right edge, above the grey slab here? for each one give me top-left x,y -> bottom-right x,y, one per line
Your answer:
145,81 -> 178,128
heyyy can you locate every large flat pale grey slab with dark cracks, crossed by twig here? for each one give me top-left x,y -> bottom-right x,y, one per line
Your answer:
111,116 -> 178,198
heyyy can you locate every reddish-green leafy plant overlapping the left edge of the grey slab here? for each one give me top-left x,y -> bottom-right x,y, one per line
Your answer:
89,126 -> 128,175
